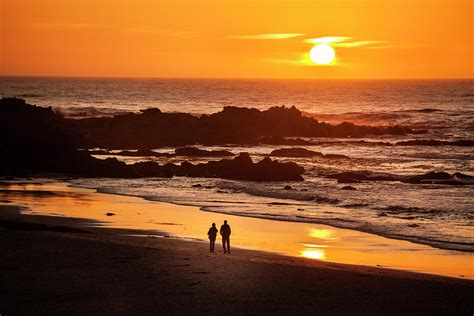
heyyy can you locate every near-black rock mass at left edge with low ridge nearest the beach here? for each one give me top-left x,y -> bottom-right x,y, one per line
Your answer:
0,98 -> 304,181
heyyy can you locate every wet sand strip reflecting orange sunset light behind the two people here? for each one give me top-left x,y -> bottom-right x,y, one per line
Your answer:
0,181 -> 474,279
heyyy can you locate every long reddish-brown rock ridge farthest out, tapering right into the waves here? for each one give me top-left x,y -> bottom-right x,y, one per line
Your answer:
71,106 -> 414,148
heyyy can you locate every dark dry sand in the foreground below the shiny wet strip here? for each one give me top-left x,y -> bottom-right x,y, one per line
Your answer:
0,206 -> 474,315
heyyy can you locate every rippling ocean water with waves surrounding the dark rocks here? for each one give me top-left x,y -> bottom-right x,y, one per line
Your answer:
0,77 -> 474,251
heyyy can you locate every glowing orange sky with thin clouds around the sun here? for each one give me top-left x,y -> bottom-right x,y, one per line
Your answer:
0,0 -> 474,79
